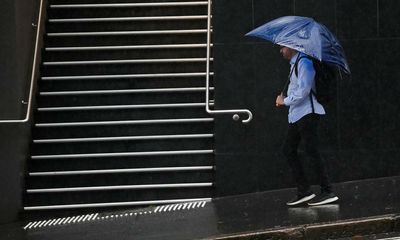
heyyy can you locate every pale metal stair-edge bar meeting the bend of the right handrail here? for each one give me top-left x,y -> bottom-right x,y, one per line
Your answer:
38,103 -> 213,112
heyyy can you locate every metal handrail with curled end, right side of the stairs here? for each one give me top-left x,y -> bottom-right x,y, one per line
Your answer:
206,0 -> 253,123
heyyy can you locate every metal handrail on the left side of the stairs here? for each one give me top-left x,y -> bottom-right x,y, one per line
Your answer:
0,0 -> 43,124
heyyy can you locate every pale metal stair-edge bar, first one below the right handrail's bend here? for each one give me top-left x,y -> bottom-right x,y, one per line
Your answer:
35,118 -> 214,127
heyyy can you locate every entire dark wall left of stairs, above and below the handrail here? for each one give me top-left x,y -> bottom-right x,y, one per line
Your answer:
0,0 -> 39,223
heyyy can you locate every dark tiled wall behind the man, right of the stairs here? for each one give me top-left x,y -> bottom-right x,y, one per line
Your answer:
213,0 -> 400,196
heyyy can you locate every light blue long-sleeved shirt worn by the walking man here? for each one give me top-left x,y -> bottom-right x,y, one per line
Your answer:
284,53 -> 325,123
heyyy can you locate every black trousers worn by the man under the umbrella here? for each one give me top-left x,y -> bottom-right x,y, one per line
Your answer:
283,114 -> 332,194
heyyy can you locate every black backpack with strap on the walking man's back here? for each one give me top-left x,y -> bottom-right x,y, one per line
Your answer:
295,56 -> 338,105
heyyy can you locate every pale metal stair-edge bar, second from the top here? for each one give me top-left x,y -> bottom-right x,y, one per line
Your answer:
49,15 -> 207,23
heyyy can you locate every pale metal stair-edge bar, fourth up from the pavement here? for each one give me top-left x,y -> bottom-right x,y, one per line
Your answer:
31,150 -> 214,159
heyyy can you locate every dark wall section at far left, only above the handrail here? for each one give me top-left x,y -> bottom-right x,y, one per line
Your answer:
0,0 -> 37,120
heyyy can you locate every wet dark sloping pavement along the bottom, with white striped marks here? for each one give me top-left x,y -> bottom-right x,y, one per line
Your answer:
0,177 -> 400,240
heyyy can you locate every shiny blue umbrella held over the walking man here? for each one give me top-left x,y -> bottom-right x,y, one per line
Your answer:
246,16 -> 350,74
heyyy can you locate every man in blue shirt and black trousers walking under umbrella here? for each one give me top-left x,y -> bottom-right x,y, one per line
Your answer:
276,47 -> 339,206
